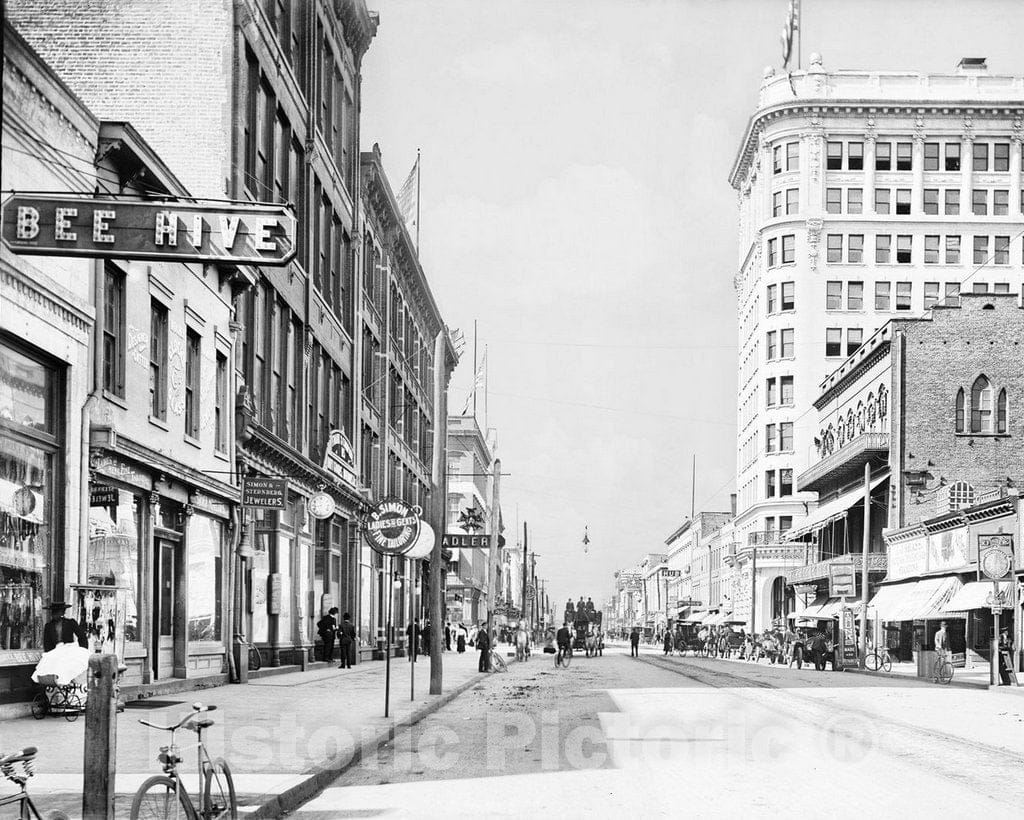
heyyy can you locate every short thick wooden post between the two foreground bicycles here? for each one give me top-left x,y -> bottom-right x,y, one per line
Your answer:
82,655 -> 118,820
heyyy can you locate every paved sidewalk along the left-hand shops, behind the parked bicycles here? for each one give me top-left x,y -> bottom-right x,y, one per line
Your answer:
0,646 -> 495,817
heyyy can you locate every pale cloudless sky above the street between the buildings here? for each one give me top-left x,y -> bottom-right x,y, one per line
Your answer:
360,0 -> 1024,604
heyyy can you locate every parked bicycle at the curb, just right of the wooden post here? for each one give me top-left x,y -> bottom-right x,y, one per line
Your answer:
131,703 -> 239,820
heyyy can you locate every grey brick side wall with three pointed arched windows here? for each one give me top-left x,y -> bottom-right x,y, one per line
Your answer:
899,294 -> 1024,525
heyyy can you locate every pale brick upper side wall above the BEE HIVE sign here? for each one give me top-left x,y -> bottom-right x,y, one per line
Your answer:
5,0 -> 232,198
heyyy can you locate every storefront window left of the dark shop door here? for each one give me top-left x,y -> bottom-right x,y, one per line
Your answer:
86,482 -> 142,641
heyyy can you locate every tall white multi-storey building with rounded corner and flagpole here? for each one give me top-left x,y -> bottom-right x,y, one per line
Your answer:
730,54 -> 1024,614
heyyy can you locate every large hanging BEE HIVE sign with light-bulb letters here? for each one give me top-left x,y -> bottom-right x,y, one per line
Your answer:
2,195 -> 295,267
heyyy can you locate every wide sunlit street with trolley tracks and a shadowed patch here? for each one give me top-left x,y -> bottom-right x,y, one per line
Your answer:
290,647 -> 1024,820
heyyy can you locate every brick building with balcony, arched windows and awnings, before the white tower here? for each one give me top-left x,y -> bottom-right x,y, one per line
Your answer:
788,293 -> 1024,671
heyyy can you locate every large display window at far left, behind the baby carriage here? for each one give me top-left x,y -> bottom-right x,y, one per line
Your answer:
0,343 -> 63,657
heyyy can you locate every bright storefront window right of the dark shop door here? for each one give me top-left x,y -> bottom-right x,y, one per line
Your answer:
188,513 -> 224,641
